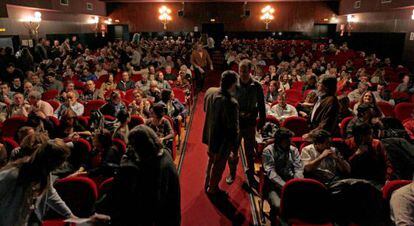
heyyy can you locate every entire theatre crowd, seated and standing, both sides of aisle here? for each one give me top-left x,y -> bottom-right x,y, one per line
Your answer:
0,34 -> 414,225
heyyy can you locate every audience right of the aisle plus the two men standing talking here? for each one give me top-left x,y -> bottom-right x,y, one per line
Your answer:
203,38 -> 414,225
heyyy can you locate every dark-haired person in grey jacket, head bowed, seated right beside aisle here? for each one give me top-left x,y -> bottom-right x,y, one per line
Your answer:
263,128 -> 303,225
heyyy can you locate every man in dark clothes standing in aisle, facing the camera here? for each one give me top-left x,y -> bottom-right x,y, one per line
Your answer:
226,60 -> 266,187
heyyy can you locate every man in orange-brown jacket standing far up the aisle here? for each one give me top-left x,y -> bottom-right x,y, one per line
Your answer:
190,43 -> 214,92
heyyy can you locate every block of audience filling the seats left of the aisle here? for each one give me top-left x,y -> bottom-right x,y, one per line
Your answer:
0,35 -> 213,225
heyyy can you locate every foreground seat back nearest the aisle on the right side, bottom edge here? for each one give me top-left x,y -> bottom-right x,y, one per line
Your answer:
280,179 -> 331,224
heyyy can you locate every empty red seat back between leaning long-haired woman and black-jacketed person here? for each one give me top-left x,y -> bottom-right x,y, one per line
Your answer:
54,177 -> 98,217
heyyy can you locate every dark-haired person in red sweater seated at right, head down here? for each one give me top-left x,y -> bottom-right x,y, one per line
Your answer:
345,123 -> 393,187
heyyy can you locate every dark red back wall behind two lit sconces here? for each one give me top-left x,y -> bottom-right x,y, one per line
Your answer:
107,2 -> 333,32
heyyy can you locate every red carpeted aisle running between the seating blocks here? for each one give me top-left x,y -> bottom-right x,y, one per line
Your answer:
180,74 -> 252,226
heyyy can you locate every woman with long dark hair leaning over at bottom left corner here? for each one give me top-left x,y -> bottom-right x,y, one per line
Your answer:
0,139 -> 75,226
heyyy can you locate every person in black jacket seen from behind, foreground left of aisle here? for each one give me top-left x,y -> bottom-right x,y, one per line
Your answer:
98,125 -> 181,226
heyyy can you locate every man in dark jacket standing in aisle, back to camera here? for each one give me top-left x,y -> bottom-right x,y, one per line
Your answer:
203,71 -> 239,195
